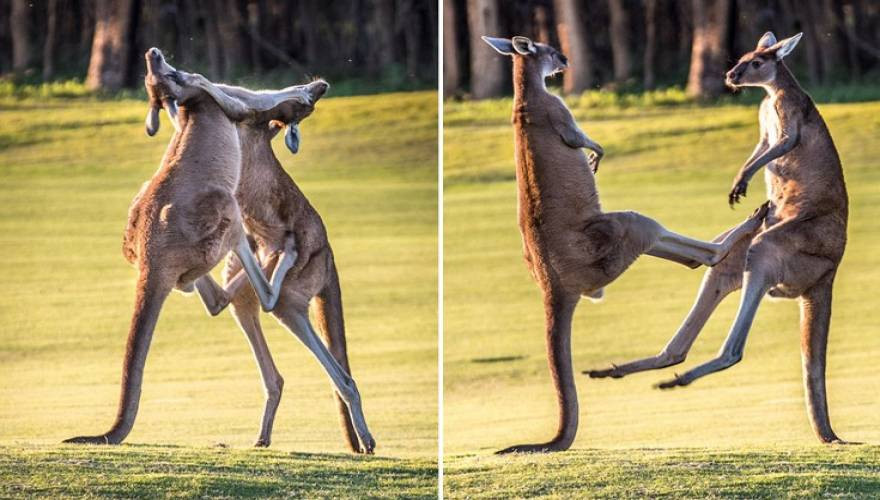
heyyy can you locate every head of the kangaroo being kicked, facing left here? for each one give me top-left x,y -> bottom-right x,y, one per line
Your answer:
726,31 -> 803,88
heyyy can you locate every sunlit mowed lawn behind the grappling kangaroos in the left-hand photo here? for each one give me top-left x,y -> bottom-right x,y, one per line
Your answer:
0,92 -> 438,497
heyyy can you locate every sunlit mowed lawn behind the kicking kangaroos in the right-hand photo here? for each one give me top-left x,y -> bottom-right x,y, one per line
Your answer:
444,94 -> 880,497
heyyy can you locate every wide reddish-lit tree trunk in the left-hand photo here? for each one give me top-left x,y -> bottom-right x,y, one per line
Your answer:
86,0 -> 134,90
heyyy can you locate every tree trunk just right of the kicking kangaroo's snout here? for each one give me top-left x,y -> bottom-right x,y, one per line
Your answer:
553,0 -> 593,94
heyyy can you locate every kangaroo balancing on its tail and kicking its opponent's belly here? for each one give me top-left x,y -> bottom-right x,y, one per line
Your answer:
483,36 -> 766,453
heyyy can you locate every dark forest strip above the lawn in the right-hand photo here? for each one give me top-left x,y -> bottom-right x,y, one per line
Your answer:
443,0 -> 880,99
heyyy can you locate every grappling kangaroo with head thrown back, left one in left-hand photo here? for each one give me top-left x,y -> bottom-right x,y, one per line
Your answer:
65,48 -> 296,444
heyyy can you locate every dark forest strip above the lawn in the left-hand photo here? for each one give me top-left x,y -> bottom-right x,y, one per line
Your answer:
0,0 -> 438,93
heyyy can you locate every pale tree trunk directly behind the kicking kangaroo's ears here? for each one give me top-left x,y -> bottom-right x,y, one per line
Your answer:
467,0 -> 507,99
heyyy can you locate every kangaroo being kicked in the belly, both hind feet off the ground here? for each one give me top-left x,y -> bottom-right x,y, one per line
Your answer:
586,32 -> 849,443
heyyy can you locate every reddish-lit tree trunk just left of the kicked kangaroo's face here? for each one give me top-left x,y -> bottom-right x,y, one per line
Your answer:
687,0 -> 730,99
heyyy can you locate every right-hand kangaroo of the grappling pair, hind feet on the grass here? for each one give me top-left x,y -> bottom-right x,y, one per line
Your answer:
191,80 -> 376,453
